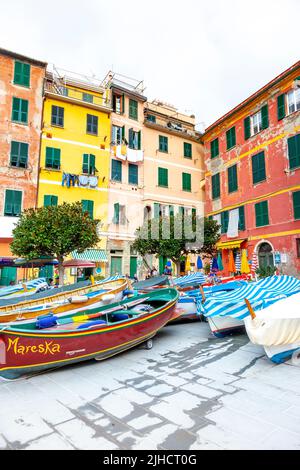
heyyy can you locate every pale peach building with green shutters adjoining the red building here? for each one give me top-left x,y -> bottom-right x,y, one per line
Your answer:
143,100 -> 205,273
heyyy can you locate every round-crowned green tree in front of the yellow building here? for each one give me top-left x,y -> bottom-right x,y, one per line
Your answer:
10,202 -> 100,284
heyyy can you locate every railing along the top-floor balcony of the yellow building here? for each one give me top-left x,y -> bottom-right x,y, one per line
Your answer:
45,81 -> 111,109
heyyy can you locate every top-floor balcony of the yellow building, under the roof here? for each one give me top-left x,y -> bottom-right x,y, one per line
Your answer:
45,80 -> 112,112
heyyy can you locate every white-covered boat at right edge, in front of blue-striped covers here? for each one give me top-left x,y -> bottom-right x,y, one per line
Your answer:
245,292 -> 300,365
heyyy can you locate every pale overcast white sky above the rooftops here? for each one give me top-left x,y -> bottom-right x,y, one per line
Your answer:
0,0 -> 300,129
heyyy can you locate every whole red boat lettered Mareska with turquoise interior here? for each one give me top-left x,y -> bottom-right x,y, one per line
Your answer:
0,288 -> 178,379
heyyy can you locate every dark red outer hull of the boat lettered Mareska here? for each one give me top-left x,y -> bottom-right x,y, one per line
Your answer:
0,299 -> 177,379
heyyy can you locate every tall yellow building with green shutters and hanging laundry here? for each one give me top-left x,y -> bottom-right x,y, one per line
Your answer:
38,69 -> 111,281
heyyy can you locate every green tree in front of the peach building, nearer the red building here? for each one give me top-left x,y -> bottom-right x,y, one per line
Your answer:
132,215 -> 220,274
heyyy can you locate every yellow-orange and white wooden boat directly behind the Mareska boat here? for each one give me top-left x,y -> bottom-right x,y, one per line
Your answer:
0,278 -> 128,323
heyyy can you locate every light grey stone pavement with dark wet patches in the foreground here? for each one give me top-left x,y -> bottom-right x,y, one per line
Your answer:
0,322 -> 300,450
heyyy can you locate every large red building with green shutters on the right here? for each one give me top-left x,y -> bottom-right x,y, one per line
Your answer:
203,61 -> 300,276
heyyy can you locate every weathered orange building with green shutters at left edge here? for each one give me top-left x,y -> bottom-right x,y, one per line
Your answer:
0,49 -> 47,285
